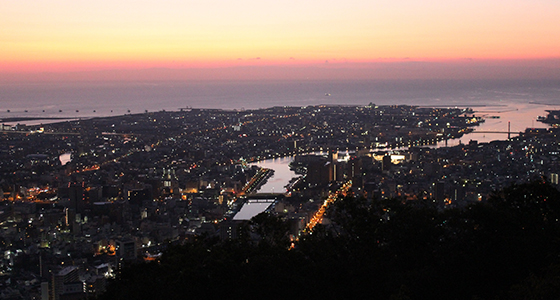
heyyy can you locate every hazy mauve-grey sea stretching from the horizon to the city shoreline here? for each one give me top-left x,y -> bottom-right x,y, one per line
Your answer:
0,80 -> 560,143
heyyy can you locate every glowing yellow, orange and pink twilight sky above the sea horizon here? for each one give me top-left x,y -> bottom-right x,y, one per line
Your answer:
0,0 -> 560,81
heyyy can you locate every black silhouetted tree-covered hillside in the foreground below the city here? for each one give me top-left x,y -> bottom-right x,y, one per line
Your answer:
98,182 -> 560,299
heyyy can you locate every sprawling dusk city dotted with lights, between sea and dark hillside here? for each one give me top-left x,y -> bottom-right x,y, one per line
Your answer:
0,104 -> 560,299
